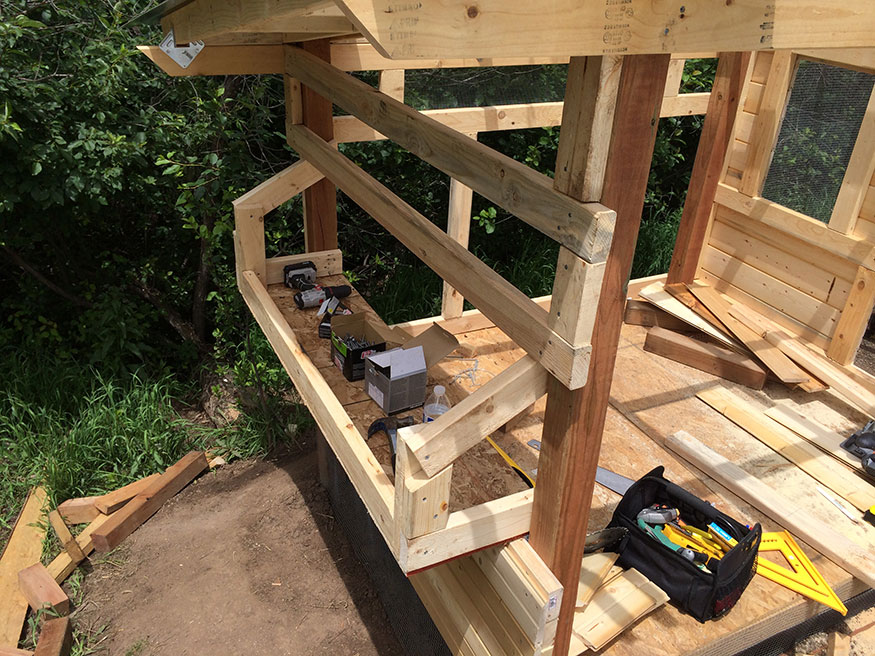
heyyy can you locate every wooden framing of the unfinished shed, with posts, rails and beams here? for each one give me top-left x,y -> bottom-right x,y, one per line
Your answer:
139,0 -> 875,656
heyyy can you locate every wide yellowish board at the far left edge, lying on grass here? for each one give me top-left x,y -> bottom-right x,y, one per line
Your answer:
0,487 -> 47,647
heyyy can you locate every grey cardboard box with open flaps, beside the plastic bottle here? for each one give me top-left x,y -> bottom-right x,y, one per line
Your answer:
365,324 -> 459,414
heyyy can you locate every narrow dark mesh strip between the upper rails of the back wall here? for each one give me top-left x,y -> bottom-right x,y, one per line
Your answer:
404,64 -> 568,111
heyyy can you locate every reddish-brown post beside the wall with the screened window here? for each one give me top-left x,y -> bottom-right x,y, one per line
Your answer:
666,52 -> 751,284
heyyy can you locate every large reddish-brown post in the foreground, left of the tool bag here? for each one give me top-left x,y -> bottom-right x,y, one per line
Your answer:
530,55 -> 670,656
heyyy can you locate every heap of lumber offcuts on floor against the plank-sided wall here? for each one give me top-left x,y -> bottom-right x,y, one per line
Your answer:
626,281 -> 875,416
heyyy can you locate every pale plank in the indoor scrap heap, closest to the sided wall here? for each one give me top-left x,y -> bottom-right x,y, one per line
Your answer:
733,305 -> 875,417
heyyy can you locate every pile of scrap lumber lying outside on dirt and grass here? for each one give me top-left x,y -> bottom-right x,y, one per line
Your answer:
0,451 -> 208,656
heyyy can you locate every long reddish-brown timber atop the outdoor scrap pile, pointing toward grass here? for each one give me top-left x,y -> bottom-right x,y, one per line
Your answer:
91,452 -> 209,553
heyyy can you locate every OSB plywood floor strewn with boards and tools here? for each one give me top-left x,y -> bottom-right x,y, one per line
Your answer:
270,277 -> 875,656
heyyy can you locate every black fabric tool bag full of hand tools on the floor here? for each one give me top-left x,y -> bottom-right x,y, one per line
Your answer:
609,467 -> 762,623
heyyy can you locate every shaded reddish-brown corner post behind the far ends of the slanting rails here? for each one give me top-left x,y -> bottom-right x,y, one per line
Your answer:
301,39 -> 337,253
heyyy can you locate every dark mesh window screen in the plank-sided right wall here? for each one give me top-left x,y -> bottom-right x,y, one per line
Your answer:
763,59 -> 875,223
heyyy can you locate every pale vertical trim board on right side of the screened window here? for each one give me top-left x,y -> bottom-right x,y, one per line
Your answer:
829,86 -> 875,234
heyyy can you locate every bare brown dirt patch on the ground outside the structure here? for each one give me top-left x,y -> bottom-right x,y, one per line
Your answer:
73,444 -> 403,656
